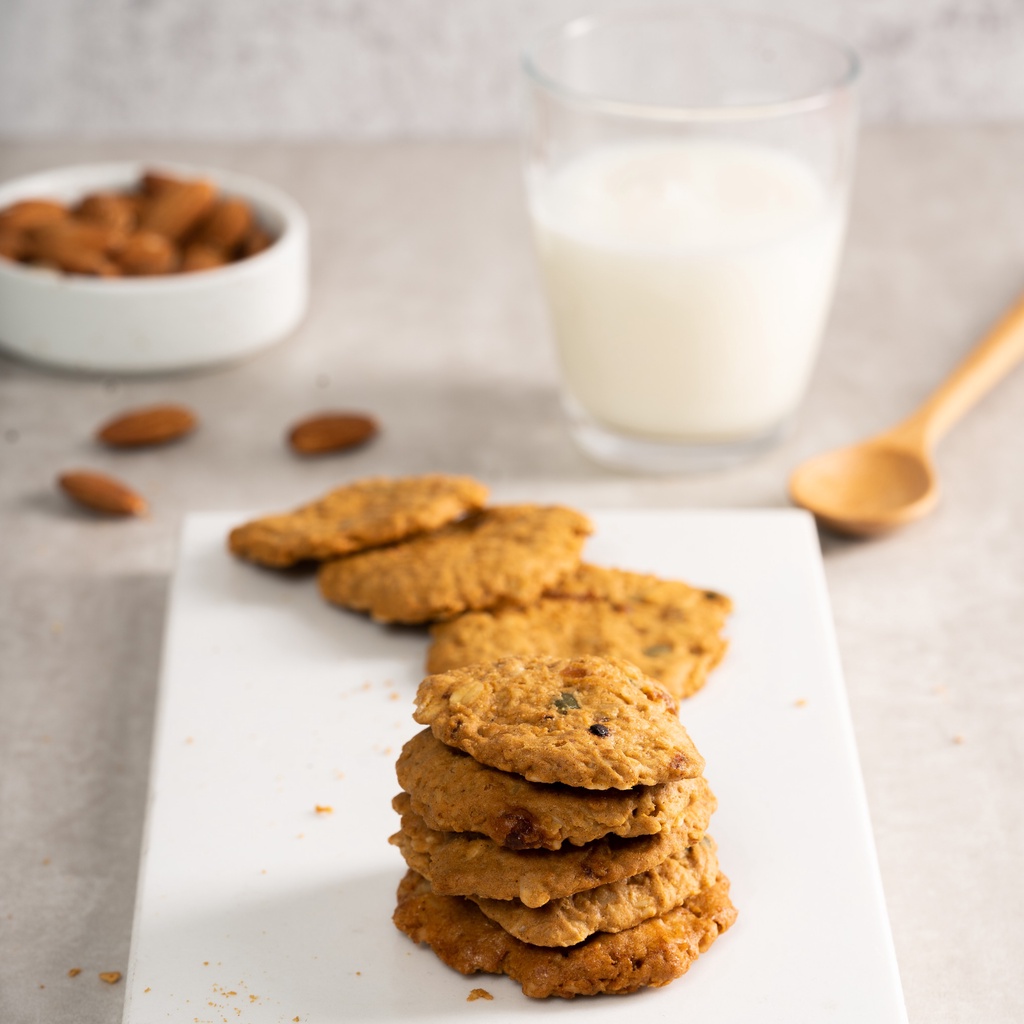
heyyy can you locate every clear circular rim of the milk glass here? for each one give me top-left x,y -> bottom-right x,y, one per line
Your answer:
520,4 -> 861,122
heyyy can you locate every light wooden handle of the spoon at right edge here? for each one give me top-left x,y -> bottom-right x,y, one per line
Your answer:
897,296 -> 1024,446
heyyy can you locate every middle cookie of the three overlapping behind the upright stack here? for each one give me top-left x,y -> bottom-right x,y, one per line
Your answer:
319,505 -> 592,623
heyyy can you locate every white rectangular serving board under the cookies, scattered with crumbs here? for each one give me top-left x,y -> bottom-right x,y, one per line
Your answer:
124,511 -> 906,1024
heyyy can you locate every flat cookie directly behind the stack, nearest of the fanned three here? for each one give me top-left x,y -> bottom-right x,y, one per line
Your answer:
427,565 -> 732,699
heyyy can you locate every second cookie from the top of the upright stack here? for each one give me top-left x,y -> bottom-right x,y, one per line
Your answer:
396,729 -> 710,850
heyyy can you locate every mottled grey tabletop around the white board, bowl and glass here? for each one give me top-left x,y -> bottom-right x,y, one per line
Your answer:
0,126 -> 1024,1024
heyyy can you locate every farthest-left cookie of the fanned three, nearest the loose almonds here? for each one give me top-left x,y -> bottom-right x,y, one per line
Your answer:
228,473 -> 487,568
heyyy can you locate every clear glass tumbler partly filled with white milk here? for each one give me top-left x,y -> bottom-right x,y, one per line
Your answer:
523,5 -> 858,473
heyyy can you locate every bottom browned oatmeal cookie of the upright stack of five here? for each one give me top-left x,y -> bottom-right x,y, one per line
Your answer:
393,871 -> 736,998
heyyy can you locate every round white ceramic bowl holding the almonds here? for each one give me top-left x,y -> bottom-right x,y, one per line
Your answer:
0,162 -> 309,374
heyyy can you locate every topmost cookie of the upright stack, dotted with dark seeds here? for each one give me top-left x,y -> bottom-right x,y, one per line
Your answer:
413,656 -> 703,790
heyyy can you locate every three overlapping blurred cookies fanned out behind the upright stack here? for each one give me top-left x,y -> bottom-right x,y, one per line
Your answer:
229,474 -> 731,700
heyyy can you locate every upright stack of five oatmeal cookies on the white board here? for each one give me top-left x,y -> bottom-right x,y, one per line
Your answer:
391,656 -> 735,997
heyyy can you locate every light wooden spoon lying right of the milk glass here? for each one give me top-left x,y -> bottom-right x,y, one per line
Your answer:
790,297 -> 1024,537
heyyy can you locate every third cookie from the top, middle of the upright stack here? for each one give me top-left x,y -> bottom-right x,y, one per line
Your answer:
389,793 -> 715,906
